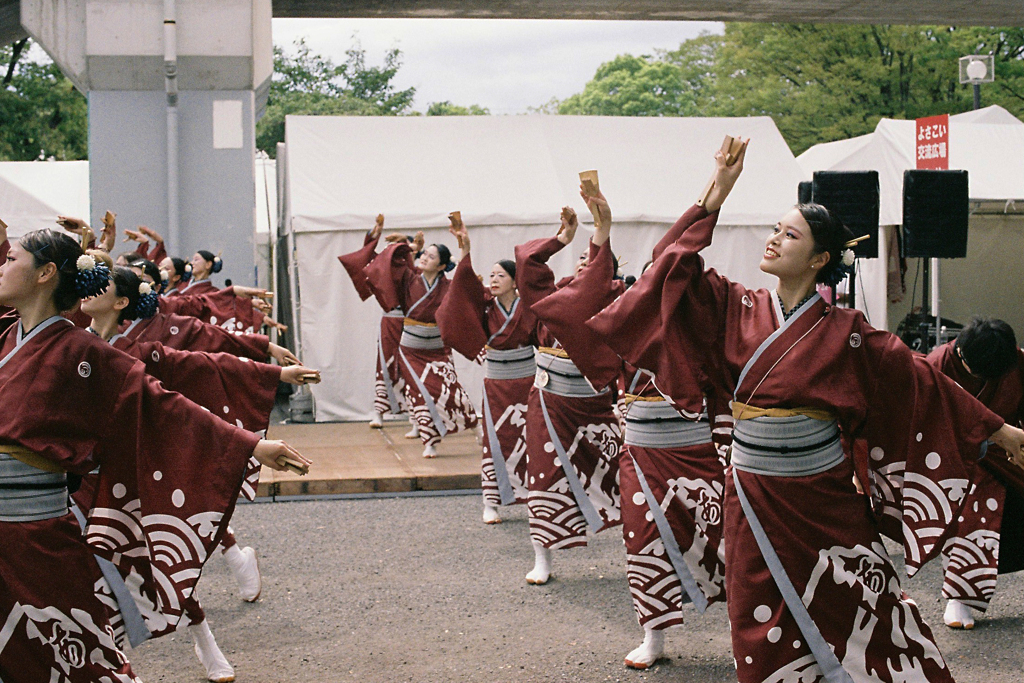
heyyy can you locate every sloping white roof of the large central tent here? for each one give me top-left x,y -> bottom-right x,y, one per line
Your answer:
286,115 -> 802,231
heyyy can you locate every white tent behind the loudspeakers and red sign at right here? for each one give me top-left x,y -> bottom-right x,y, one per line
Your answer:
797,105 -> 1024,333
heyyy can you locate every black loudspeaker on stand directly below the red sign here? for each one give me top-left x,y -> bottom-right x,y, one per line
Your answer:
903,171 -> 970,258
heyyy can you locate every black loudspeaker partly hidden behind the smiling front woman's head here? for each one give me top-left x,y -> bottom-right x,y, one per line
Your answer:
811,171 -> 879,258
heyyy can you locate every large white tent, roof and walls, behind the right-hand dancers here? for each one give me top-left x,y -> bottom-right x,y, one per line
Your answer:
278,116 -> 802,421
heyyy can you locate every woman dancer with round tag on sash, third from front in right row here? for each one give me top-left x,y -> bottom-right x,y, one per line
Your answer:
515,207 -> 623,585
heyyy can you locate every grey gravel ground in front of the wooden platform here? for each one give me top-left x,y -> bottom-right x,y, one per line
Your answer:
129,495 -> 1024,683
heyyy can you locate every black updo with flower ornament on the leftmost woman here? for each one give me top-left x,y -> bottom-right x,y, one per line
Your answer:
17,229 -> 110,311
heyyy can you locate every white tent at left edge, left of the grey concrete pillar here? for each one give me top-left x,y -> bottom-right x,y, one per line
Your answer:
0,161 -> 89,238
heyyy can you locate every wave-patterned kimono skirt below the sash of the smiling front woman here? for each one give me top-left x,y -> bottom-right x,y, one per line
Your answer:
725,459 -> 953,683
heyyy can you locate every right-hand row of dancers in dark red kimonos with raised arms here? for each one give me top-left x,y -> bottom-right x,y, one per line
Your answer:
339,141 -> 1024,683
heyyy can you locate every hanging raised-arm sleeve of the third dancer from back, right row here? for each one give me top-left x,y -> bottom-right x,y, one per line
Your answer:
435,254 -> 488,360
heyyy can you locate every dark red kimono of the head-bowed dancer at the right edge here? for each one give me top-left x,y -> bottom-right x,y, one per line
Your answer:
928,342 -> 1024,611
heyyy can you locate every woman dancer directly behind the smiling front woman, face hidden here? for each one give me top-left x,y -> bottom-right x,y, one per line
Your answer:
551,194 -> 725,669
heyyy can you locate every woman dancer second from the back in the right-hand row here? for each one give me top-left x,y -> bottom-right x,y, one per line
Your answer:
365,222 -> 477,458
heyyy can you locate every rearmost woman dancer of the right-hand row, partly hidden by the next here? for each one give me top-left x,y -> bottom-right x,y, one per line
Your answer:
338,214 -> 411,428
